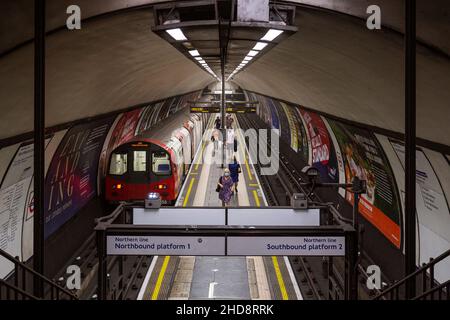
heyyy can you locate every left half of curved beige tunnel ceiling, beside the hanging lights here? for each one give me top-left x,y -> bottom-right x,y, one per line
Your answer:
0,9 -> 212,138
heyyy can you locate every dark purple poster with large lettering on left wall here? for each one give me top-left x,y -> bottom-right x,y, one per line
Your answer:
44,117 -> 113,238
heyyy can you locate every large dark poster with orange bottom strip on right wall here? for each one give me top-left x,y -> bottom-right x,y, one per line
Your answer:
328,120 -> 401,248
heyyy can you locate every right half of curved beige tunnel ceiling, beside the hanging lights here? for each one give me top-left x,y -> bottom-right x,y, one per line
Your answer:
234,8 -> 450,145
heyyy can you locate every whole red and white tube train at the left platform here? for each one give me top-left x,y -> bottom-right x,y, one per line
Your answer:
105,108 -> 209,204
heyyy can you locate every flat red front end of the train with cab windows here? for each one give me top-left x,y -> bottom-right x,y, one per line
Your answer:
105,142 -> 177,203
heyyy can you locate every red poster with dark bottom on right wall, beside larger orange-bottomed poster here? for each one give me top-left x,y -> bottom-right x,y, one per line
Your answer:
300,108 -> 339,182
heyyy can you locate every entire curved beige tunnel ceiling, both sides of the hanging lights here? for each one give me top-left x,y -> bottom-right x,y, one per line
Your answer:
0,0 -> 450,145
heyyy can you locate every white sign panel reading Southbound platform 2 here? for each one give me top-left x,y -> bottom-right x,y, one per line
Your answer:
227,236 -> 345,256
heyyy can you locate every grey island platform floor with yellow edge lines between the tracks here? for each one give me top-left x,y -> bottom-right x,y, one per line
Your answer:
139,116 -> 302,300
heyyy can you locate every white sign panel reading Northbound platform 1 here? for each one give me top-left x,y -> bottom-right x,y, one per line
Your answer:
106,235 -> 225,256
